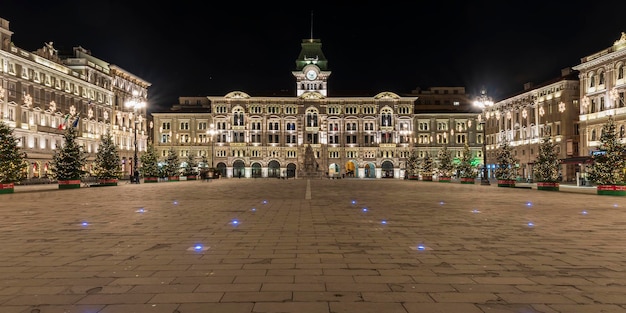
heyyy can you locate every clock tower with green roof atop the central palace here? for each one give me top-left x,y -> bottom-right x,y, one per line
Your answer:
292,39 -> 330,97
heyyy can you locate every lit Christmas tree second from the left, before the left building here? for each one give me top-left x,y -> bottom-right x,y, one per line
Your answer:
51,126 -> 87,180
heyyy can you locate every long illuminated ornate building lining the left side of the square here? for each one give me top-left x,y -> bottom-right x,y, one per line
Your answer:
0,19 -> 150,179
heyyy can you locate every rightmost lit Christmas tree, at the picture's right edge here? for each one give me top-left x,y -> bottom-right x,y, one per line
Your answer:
587,115 -> 626,185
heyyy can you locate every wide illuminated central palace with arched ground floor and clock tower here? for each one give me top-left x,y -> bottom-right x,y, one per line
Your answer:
152,39 -> 482,178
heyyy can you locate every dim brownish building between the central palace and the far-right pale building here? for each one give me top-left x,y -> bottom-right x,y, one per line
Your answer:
482,69 -> 581,182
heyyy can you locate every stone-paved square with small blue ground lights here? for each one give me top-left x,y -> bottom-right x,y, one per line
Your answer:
0,179 -> 626,313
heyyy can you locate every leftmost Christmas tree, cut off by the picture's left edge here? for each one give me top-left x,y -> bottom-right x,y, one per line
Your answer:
0,121 -> 26,183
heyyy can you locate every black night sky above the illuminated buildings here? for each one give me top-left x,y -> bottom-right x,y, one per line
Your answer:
0,0 -> 626,112
